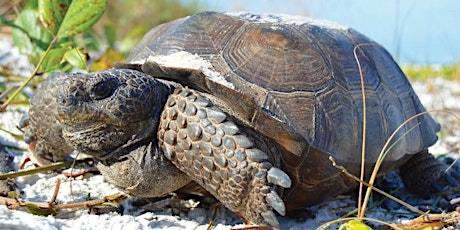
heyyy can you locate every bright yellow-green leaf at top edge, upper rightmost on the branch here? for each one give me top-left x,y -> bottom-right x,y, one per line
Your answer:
57,0 -> 107,38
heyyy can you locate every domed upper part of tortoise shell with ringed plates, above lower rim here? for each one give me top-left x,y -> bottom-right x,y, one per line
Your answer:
128,12 -> 439,168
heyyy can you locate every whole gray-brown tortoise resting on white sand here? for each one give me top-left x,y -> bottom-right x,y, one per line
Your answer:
23,12 -> 452,226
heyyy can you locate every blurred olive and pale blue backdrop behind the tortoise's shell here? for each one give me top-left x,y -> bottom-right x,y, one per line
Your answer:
0,0 -> 460,79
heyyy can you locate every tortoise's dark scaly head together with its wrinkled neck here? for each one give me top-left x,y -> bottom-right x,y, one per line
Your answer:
56,70 -> 196,197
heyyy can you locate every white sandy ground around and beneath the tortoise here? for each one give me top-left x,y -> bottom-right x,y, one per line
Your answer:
0,38 -> 460,229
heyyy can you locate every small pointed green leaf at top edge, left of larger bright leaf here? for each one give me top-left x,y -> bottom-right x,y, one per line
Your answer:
38,0 -> 72,35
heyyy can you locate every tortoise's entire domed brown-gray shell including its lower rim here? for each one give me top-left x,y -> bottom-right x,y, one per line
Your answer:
118,12 -> 440,209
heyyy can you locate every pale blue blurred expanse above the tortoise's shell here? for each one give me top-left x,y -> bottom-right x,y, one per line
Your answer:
182,0 -> 460,65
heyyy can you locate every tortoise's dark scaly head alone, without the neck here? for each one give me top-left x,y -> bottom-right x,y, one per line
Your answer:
56,69 -> 170,160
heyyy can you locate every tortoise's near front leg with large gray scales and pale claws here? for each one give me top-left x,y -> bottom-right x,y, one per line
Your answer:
158,88 -> 291,226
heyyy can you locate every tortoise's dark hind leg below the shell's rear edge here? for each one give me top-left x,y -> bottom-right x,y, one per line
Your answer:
400,150 -> 459,198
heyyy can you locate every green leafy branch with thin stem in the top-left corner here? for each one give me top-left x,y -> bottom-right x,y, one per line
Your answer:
0,0 -> 107,111
